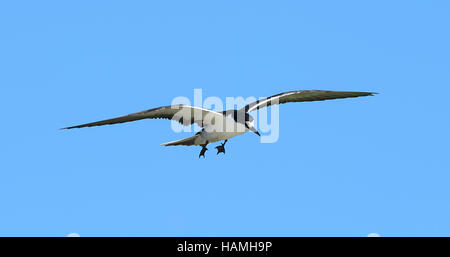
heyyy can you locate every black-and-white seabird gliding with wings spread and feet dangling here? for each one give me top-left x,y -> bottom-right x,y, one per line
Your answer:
62,90 -> 377,158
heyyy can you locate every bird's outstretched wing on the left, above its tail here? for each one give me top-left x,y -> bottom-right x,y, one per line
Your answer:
63,104 -> 224,129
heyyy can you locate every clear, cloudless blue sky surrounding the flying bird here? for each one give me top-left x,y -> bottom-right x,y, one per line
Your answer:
0,0 -> 450,236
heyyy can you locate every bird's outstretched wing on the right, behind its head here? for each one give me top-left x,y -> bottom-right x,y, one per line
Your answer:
240,90 -> 376,112
